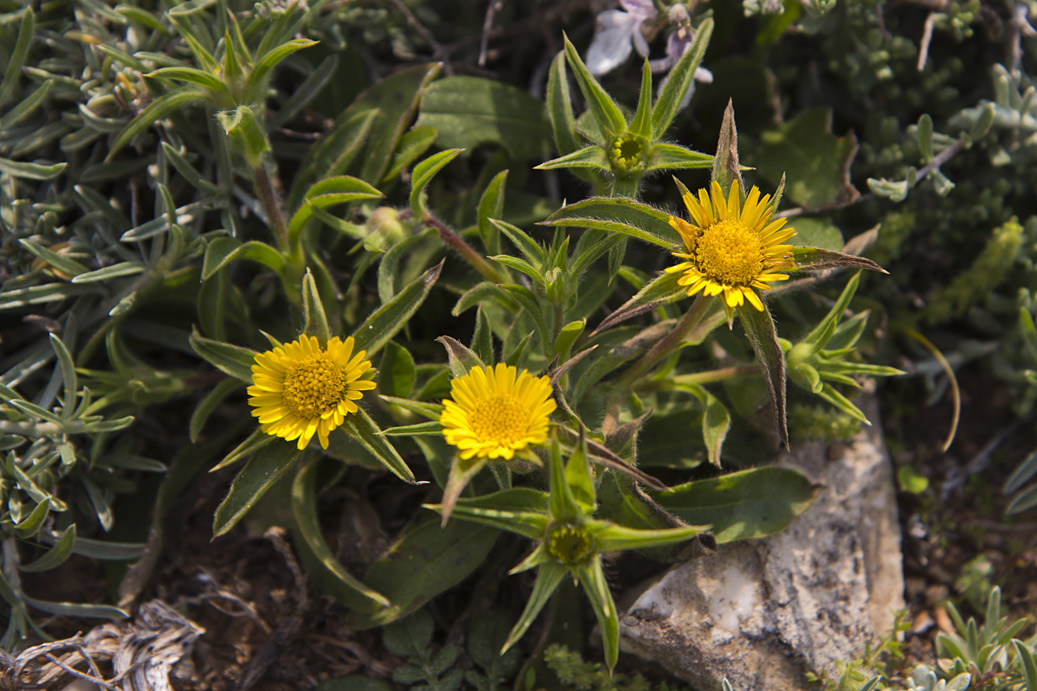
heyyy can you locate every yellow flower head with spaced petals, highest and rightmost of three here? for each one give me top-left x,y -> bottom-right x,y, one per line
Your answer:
666,181 -> 795,319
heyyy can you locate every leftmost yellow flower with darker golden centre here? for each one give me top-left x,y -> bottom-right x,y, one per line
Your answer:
248,334 -> 374,449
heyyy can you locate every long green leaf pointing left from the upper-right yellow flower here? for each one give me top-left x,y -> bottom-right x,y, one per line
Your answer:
542,197 -> 681,250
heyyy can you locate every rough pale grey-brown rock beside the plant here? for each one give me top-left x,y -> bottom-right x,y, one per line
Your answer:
621,410 -> 904,691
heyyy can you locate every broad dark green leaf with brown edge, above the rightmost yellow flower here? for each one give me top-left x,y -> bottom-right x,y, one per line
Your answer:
755,108 -> 860,209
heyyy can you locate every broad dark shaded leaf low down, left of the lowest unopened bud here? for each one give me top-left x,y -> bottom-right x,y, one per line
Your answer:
349,518 -> 500,629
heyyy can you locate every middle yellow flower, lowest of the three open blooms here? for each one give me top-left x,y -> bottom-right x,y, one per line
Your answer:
440,363 -> 557,460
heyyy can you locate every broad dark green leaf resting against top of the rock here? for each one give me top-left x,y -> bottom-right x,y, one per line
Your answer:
651,467 -> 820,543
